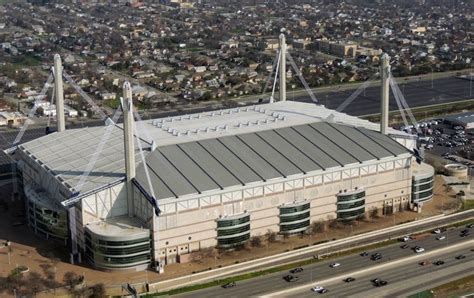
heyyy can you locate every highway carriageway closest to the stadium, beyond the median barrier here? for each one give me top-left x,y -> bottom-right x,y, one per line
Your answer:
179,227 -> 474,297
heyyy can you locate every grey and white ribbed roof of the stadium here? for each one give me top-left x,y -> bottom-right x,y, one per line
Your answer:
19,101 -> 408,198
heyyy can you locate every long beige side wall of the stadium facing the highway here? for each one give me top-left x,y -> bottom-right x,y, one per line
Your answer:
135,157 -> 412,263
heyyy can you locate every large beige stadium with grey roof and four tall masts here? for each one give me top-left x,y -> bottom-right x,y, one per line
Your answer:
15,50 -> 434,271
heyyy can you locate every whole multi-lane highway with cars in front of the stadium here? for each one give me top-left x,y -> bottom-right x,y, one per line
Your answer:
175,227 -> 474,297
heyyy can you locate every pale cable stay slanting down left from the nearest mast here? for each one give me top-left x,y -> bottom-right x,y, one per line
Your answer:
65,107 -> 122,207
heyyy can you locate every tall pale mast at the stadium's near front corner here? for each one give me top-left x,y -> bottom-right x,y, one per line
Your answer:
122,82 -> 135,217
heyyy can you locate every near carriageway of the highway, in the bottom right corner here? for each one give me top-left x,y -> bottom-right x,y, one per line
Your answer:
294,248 -> 474,297
